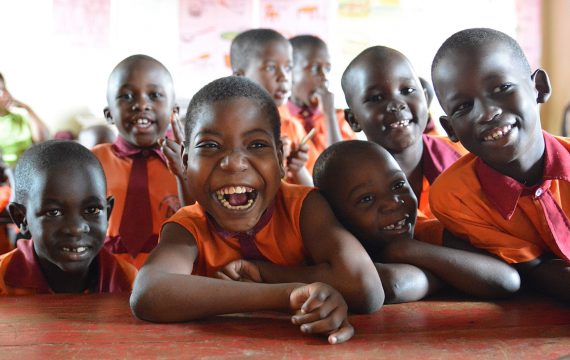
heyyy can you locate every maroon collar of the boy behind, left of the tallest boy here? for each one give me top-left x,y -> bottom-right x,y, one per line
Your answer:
422,134 -> 461,184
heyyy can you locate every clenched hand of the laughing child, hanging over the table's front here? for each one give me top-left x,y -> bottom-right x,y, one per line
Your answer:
289,283 -> 354,344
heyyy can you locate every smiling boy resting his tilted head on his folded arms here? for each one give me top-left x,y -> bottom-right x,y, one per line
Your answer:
314,140 -> 520,303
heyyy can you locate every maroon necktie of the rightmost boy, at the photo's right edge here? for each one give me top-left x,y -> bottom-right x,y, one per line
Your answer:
533,180 -> 570,261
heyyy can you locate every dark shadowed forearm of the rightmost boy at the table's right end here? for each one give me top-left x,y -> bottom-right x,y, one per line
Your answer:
515,257 -> 570,302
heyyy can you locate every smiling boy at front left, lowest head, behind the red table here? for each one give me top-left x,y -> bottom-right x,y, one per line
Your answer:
0,140 -> 137,295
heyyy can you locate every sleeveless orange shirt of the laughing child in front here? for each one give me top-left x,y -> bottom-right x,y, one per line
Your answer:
164,182 -> 313,277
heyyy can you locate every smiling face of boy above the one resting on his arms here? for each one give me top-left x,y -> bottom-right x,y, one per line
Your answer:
345,49 -> 428,153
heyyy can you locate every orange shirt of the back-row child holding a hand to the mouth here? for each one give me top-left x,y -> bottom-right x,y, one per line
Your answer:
287,101 -> 356,154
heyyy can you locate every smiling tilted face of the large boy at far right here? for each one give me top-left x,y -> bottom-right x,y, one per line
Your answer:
433,41 -> 549,169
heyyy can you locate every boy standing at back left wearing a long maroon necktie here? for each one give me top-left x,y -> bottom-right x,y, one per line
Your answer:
93,55 -> 184,268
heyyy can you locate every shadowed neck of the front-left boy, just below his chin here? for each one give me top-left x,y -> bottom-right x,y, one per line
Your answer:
39,259 -> 93,293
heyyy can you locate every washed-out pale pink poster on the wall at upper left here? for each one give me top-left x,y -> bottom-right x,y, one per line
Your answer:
53,0 -> 110,48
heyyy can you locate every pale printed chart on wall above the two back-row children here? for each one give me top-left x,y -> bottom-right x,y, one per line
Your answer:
259,0 -> 335,41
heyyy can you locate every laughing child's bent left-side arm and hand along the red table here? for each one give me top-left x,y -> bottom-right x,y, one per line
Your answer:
130,223 -> 354,343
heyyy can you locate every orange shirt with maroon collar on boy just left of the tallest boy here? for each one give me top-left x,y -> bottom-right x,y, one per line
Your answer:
414,134 -> 467,245
